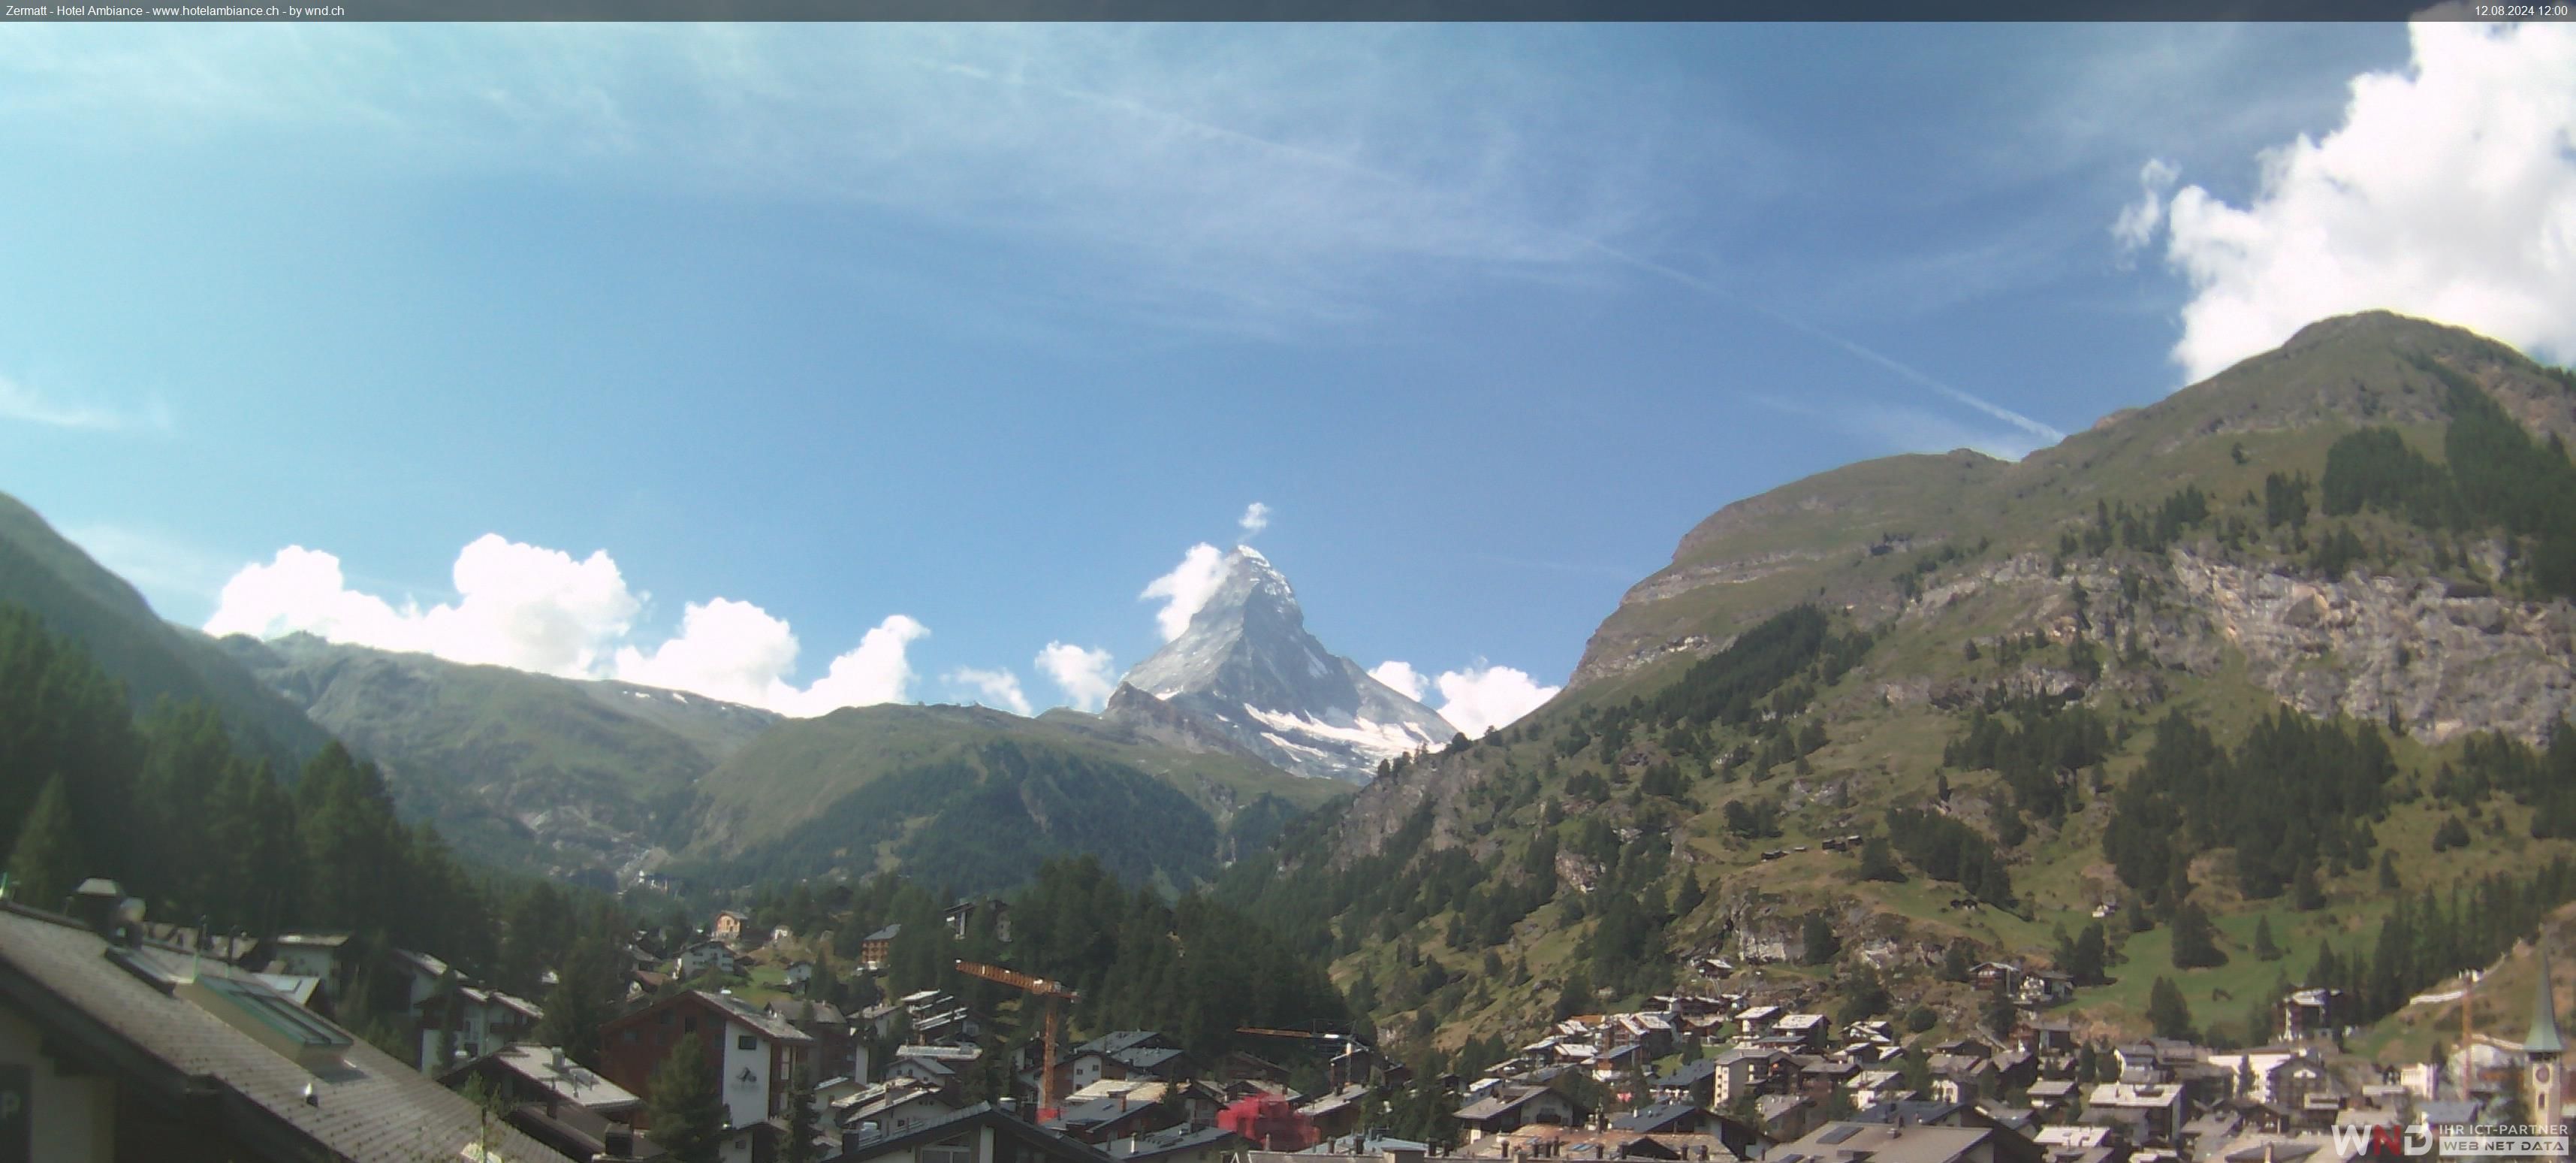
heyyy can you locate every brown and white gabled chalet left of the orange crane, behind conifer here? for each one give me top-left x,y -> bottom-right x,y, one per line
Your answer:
600,990 -> 814,1127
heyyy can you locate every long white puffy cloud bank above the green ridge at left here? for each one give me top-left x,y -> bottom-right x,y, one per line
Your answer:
206,534 -> 930,714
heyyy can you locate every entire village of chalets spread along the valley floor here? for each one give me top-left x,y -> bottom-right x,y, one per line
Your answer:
0,879 -> 2568,1163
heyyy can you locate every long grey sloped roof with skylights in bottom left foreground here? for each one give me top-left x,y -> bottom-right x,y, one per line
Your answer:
0,905 -> 559,1163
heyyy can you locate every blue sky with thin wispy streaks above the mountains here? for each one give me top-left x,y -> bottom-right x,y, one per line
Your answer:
0,26 -> 2563,722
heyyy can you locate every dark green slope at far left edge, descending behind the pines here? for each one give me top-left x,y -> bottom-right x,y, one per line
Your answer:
0,495 -> 324,771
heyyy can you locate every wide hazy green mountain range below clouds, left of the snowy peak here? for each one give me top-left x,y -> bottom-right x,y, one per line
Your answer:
224,634 -> 1335,887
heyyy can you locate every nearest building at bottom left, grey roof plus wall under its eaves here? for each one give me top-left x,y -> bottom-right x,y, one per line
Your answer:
0,902 -> 562,1163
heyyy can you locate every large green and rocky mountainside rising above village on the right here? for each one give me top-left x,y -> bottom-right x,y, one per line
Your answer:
1223,315 -> 2576,1050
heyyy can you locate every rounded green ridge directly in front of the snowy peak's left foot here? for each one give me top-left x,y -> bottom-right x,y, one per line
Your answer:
688,706 -> 1347,890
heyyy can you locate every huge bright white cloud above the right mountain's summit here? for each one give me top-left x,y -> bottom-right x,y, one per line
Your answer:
2115,20 -> 2576,379
